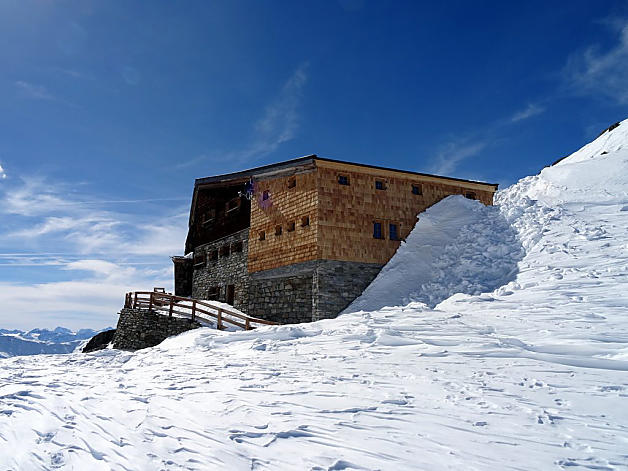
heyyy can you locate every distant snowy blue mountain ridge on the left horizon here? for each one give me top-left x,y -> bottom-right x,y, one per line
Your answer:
0,327 -> 110,358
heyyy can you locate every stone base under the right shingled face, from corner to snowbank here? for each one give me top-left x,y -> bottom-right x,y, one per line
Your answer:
312,260 -> 382,321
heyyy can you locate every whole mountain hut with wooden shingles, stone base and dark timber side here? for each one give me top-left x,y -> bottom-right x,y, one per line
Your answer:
173,155 -> 497,323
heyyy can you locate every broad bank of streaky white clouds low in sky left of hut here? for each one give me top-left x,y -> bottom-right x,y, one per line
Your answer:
0,174 -> 187,328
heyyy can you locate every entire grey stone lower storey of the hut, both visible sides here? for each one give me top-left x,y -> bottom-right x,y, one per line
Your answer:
173,229 -> 382,324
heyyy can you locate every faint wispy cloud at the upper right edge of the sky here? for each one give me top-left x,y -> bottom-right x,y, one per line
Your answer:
563,19 -> 628,104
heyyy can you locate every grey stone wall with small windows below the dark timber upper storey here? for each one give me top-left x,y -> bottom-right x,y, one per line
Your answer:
192,228 -> 249,312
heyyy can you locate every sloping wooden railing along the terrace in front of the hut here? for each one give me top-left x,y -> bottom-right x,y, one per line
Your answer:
124,288 -> 277,330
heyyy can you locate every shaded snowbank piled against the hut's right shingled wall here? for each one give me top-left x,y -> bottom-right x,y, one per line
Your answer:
345,196 -> 523,312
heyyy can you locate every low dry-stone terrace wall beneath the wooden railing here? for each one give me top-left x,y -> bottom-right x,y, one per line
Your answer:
113,308 -> 201,350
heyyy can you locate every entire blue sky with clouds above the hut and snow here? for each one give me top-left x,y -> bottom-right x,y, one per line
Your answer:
0,0 -> 628,328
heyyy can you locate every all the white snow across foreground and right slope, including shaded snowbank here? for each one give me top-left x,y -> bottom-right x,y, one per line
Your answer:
0,122 -> 628,470
